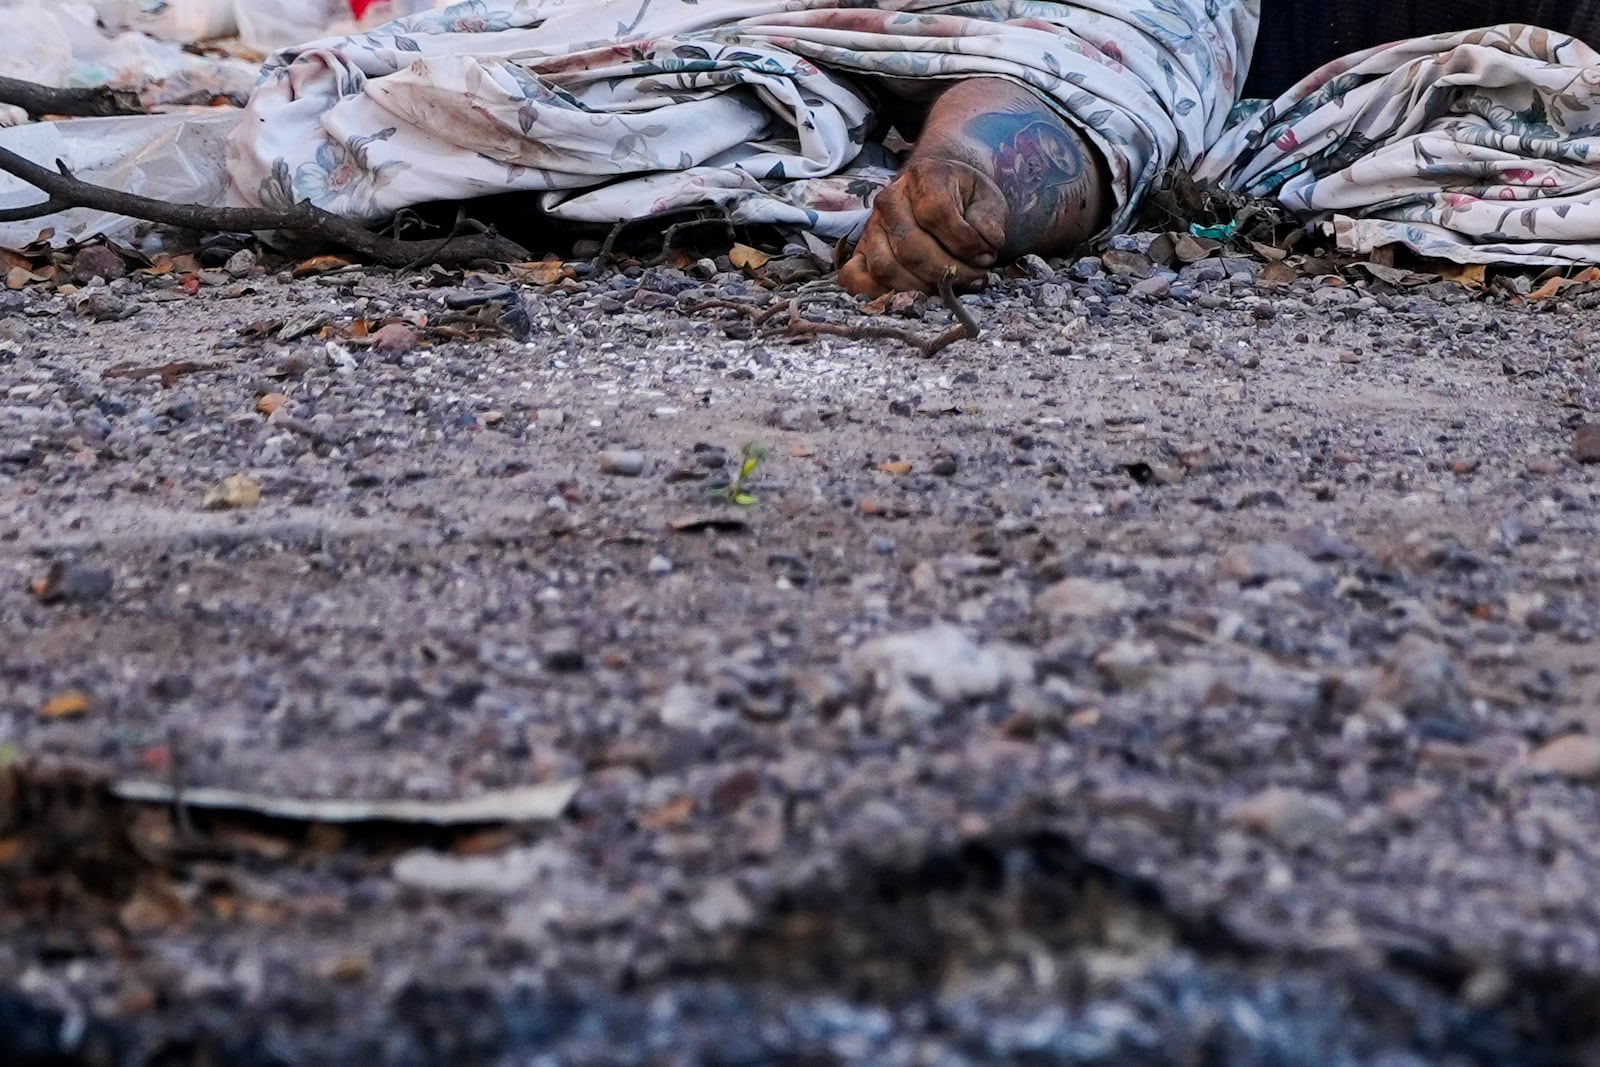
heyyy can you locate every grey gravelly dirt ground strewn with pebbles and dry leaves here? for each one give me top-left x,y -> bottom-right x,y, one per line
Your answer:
0,241 -> 1600,1067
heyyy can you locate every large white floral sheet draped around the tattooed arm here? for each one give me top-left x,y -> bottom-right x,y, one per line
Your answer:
229,0 -> 1259,237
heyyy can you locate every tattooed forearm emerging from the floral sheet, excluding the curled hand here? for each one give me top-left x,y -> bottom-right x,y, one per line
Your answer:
912,78 -> 1112,259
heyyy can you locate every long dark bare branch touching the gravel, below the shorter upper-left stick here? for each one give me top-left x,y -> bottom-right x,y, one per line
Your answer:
0,149 -> 530,267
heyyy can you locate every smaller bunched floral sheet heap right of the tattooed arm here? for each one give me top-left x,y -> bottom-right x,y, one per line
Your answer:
1195,26 -> 1600,266
